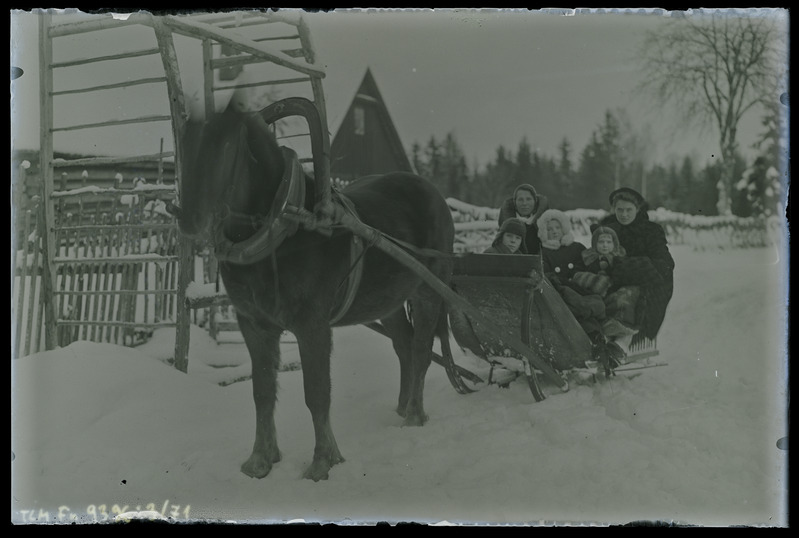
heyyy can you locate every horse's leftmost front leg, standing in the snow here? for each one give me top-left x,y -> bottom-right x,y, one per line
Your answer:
238,314 -> 282,478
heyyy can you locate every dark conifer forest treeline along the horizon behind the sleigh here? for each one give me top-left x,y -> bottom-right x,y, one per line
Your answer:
410,107 -> 785,217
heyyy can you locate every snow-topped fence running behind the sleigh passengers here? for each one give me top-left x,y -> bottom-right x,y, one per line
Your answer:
447,198 -> 784,252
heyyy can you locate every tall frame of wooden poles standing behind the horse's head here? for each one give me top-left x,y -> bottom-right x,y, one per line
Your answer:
39,10 -> 330,372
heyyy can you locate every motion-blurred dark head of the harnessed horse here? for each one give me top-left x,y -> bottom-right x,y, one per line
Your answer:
172,105 -> 284,238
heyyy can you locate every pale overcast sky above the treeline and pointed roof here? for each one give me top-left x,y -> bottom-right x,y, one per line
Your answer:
12,10 -> 787,166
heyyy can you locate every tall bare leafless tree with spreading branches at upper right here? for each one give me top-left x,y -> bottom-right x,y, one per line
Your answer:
640,11 -> 787,215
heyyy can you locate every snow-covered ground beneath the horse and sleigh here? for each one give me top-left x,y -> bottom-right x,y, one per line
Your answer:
11,246 -> 788,526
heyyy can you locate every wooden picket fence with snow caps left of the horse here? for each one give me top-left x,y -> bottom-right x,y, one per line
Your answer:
12,165 -> 179,356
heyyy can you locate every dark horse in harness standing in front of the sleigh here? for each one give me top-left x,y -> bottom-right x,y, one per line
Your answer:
172,101 -> 454,481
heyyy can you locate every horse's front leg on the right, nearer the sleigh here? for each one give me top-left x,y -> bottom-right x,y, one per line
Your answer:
294,322 -> 344,481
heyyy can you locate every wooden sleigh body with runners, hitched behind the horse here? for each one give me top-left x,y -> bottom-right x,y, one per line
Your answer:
449,254 -> 662,401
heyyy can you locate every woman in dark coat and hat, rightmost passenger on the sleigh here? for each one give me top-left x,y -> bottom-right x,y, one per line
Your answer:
600,187 -> 674,344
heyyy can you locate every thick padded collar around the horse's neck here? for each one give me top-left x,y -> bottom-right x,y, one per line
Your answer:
213,147 -> 305,265
